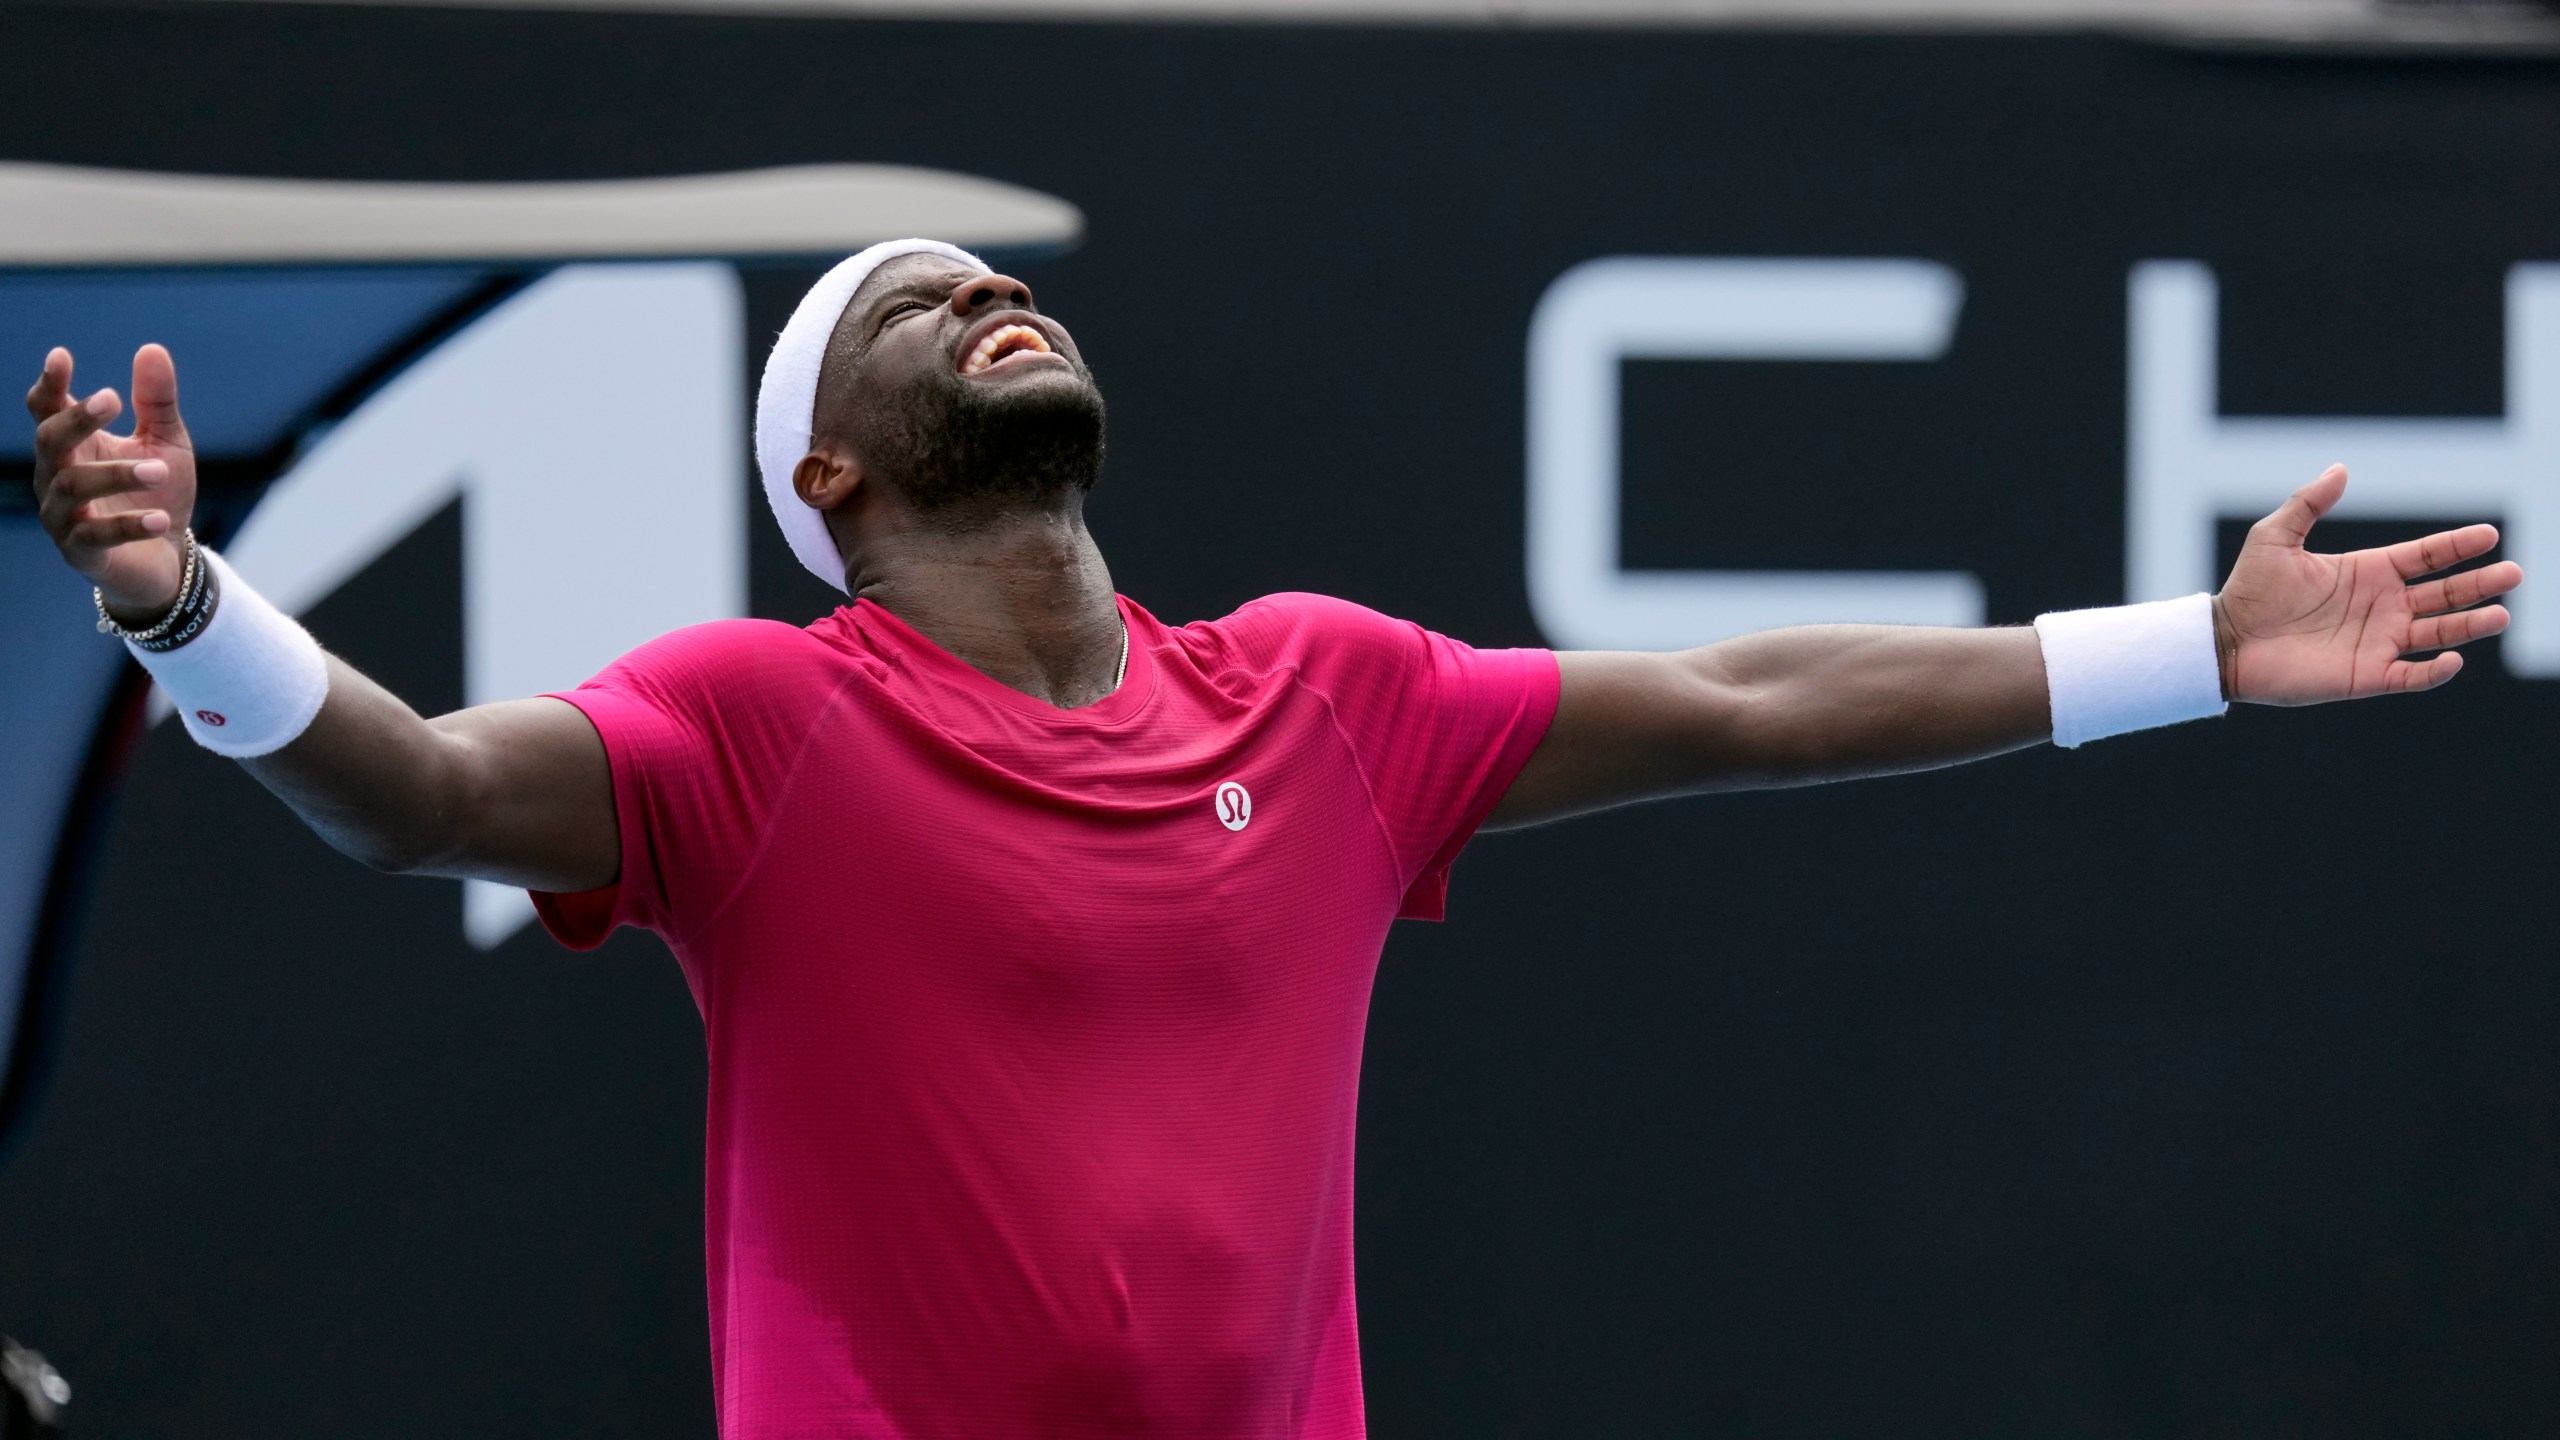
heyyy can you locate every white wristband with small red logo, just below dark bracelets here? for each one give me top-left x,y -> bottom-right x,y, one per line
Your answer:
125,551 -> 328,758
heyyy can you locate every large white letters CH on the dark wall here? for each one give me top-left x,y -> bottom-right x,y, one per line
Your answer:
1528,256 -> 2560,679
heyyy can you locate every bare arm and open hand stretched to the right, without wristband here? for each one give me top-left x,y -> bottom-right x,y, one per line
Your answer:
1492,466 -> 2524,825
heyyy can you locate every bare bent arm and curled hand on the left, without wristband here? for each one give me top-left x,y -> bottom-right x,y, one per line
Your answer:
26,346 -> 622,894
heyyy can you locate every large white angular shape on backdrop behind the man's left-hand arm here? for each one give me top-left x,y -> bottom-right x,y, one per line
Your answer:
228,264 -> 748,948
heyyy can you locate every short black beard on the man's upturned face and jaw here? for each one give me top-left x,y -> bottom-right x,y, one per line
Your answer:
850,361 -> 1103,528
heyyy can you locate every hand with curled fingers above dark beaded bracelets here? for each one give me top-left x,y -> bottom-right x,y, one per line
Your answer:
26,346 -> 195,623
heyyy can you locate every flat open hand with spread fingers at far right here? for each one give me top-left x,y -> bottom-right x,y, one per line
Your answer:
2214,464 -> 2524,705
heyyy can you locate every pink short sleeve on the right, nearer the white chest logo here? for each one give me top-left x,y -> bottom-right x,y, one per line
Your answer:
1247,594 -> 1562,920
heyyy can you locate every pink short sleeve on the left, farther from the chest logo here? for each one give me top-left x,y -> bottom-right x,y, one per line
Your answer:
532,620 -> 806,951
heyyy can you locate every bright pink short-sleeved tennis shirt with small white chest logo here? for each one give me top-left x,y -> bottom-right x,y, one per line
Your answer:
535,594 -> 1556,1440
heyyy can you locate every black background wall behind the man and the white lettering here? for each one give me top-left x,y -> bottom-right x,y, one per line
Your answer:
0,5 -> 2560,1437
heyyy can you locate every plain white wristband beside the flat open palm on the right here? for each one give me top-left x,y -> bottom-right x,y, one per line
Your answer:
2035,594 -> 2230,748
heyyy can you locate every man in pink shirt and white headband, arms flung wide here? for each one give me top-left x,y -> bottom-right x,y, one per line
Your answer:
28,241 -> 2522,1440
